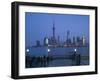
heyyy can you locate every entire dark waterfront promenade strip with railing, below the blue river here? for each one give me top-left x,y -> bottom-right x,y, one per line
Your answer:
26,54 -> 89,68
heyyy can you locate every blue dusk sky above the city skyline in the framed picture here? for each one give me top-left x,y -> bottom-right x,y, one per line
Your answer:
25,12 -> 89,46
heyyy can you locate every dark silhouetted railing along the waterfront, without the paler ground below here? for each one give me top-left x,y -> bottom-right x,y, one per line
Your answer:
26,54 -> 89,68
